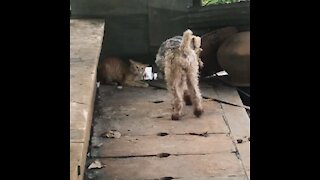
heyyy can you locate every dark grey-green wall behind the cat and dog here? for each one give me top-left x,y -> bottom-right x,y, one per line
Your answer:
71,0 -> 192,63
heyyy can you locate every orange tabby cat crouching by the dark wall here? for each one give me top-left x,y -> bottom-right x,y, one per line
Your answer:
98,57 -> 149,87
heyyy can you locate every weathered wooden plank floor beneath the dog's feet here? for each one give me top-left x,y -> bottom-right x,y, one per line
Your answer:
85,82 -> 250,180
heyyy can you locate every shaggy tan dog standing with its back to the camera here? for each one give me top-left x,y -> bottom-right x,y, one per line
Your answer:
161,29 -> 203,120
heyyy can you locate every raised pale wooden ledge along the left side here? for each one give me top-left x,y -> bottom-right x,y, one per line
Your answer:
70,19 -> 104,180
